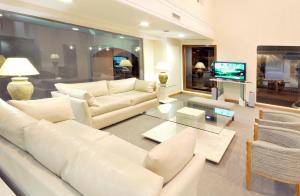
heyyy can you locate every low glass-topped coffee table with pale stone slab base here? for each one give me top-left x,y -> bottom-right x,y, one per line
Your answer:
142,101 -> 235,163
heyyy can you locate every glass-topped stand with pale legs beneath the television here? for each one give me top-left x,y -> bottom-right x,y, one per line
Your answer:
210,78 -> 251,107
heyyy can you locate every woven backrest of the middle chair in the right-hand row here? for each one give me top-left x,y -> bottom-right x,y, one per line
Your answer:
254,125 -> 300,148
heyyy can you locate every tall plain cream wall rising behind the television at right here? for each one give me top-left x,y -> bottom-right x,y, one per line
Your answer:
214,0 -> 300,101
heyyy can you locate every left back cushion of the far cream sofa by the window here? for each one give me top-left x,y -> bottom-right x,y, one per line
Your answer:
55,80 -> 108,97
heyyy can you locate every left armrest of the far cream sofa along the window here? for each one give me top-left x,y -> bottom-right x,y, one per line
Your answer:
51,91 -> 92,126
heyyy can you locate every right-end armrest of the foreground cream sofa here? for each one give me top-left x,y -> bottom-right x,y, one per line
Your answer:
160,155 -> 205,196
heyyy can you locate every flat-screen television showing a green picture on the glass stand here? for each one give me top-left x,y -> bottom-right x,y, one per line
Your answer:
213,61 -> 246,81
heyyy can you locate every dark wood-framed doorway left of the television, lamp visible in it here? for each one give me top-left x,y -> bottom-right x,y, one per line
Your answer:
182,45 -> 217,93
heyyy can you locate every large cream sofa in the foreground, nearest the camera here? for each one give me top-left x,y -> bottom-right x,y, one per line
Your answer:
0,96 -> 205,196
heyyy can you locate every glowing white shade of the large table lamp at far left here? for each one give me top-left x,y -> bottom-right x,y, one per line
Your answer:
0,58 -> 39,76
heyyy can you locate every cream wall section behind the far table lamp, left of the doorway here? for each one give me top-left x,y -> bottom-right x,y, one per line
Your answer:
144,38 -> 182,94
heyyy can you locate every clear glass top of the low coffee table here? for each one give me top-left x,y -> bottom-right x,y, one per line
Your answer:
146,100 -> 234,133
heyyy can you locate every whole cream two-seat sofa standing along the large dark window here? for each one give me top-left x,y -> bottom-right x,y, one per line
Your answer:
51,78 -> 159,129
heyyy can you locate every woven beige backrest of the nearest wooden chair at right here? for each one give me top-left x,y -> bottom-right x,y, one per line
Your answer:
249,141 -> 300,184
